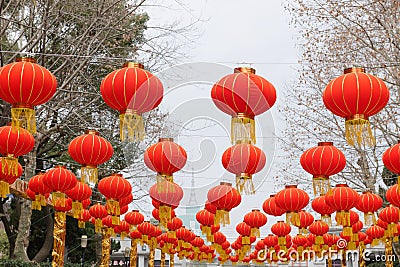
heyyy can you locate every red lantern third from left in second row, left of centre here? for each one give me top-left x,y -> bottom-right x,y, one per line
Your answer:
144,138 -> 187,184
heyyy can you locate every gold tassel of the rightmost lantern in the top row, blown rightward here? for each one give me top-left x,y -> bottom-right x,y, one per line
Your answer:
345,115 -> 375,147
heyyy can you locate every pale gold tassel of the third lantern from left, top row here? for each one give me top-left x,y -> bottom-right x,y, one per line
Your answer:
231,114 -> 256,144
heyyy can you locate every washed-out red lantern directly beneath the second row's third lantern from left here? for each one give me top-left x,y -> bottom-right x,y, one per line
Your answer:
149,180 -> 183,228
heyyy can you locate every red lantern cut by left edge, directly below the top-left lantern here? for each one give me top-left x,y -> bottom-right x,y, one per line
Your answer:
0,126 -> 35,175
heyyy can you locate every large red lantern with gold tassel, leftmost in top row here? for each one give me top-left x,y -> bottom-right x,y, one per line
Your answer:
0,57 -> 57,133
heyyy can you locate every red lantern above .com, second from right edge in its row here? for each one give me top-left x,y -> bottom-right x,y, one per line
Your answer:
356,191 -> 382,226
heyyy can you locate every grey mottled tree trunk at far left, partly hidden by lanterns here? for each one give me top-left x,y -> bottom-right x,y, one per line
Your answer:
14,151 -> 36,261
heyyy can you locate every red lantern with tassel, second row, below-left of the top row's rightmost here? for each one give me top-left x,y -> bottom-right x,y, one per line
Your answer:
300,142 -> 346,195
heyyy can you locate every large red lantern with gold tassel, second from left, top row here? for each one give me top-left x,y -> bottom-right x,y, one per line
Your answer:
100,62 -> 164,141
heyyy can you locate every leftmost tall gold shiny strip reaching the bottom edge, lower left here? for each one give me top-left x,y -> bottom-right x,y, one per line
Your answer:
51,211 -> 66,267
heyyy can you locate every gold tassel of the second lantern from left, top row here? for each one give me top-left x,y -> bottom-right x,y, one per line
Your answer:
119,110 -> 145,142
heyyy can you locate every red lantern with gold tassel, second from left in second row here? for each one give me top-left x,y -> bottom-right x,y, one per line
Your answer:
68,130 -> 114,184
